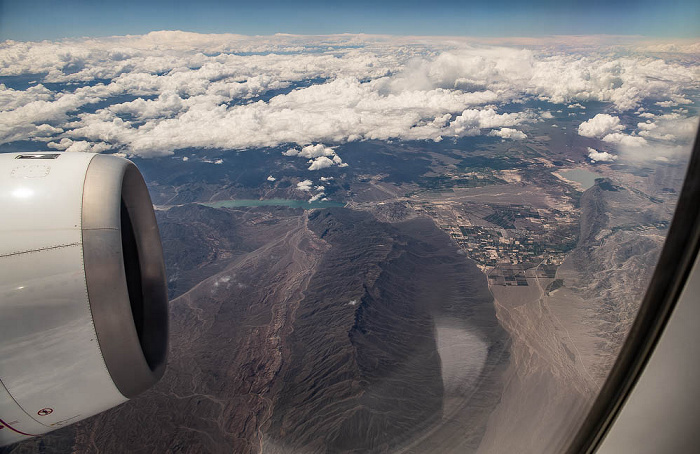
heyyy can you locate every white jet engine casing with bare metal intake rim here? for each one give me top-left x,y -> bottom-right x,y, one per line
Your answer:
0,153 -> 168,446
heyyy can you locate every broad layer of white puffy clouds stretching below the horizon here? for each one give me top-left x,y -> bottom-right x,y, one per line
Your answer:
0,32 -> 700,157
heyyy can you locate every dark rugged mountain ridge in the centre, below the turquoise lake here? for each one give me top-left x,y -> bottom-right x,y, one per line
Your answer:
264,210 -> 505,453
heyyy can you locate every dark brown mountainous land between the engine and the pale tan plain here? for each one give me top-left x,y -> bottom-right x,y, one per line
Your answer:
4,205 -> 507,453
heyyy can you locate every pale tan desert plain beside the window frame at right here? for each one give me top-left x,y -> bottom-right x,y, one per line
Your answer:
478,176 -> 672,454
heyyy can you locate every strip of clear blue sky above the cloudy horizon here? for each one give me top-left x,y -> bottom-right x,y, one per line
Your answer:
0,0 -> 700,41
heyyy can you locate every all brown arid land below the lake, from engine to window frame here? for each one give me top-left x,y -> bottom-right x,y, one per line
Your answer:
0,144 -> 680,454
